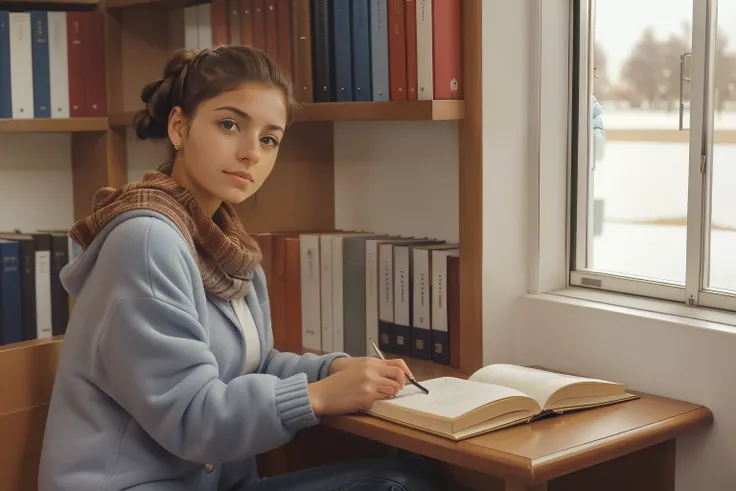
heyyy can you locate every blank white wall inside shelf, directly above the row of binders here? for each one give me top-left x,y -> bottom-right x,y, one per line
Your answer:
334,121 -> 459,242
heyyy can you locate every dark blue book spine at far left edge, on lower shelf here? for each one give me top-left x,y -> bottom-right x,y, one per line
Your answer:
0,242 -> 23,346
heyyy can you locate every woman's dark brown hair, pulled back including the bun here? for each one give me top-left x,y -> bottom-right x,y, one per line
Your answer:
133,45 -> 297,145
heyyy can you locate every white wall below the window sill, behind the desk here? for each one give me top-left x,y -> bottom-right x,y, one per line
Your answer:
516,295 -> 736,491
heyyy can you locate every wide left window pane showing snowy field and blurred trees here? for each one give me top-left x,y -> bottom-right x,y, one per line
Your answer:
587,0 -> 693,284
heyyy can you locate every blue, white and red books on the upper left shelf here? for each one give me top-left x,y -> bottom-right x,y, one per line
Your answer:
0,10 -> 107,119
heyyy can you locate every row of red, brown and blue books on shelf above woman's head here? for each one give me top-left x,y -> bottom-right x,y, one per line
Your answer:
181,0 -> 463,102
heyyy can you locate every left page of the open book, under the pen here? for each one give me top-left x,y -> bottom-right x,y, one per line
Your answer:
371,377 -> 529,420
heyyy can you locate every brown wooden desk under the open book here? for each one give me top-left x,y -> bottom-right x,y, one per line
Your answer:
258,359 -> 713,491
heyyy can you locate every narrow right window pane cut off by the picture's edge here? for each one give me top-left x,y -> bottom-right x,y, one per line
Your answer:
706,0 -> 736,291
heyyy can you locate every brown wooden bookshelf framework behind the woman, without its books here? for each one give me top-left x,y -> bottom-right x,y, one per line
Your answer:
5,0 -> 483,382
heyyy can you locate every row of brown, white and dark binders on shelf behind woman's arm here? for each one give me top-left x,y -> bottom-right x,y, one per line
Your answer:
254,231 -> 460,367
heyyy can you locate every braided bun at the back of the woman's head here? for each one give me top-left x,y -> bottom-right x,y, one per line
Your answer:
134,49 -> 196,140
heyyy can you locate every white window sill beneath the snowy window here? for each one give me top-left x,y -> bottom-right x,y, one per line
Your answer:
528,287 -> 736,334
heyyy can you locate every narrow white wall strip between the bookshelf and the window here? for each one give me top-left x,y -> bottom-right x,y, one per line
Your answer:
482,0 -> 533,363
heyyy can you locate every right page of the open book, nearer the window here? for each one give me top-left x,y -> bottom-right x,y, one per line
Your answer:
470,363 -> 620,408
